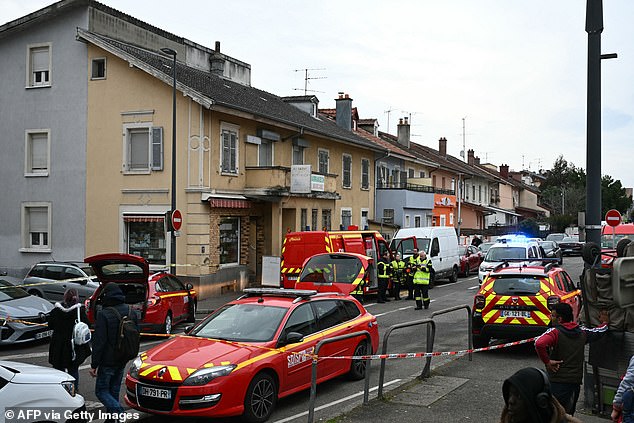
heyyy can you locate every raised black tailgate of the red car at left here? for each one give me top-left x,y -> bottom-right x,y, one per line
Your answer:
84,253 -> 150,285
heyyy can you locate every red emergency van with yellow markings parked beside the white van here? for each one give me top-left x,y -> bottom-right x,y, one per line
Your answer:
280,230 -> 392,292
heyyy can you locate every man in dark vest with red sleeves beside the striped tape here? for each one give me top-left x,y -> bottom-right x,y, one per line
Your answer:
535,303 -> 609,416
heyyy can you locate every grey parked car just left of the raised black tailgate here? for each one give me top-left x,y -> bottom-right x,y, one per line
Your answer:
21,261 -> 99,303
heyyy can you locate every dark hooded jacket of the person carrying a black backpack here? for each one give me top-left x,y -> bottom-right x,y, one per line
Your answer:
90,282 -> 138,369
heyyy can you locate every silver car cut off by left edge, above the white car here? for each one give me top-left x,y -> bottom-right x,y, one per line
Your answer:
0,279 -> 53,344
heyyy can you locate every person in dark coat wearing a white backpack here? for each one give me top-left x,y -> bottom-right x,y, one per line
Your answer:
48,288 -> 90,389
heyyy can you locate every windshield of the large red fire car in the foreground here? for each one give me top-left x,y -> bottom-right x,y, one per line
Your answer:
190,303 -> 288,342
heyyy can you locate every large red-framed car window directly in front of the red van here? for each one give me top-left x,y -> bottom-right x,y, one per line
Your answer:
299,254 -> 363,283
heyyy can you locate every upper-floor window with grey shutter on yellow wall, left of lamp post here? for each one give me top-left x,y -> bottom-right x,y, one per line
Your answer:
123,124 -> 164,173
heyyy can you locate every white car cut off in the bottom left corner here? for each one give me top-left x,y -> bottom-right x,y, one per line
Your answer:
0,360 -> 86,423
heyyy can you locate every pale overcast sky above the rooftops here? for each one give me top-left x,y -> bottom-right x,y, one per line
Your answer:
0,0 -> 634,187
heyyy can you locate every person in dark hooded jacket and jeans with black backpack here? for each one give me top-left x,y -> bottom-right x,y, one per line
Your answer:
90,282 -> 139,421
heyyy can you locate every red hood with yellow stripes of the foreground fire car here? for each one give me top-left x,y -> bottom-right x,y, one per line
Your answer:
139,337 -> 271,382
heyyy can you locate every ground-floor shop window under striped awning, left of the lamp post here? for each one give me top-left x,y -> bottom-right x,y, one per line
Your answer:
123,216 -> 167,265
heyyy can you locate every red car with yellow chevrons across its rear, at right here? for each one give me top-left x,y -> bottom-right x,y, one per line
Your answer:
472,263 -> 581,348
